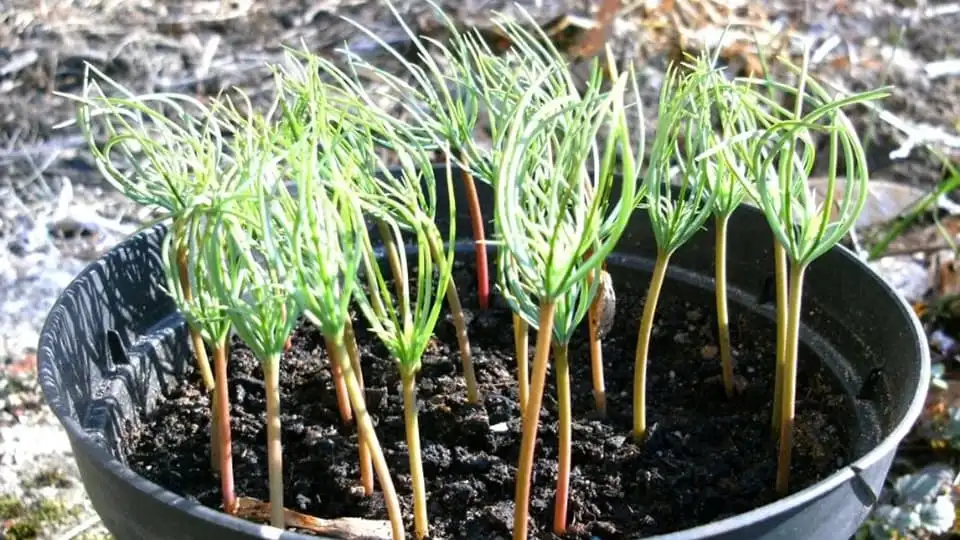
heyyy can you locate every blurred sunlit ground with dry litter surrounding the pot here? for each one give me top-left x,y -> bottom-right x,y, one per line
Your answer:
0,0 -> 960,539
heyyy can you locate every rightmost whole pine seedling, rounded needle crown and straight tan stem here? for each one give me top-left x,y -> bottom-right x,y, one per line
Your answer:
742,49 -> 888,496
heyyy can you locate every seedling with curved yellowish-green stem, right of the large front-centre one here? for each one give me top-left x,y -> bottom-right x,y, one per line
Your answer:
633,57 -> 715,441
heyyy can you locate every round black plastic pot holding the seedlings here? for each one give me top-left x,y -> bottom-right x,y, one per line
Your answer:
39,165 -> 930,540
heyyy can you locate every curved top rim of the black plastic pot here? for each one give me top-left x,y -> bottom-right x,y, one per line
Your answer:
37,207 -> 931,540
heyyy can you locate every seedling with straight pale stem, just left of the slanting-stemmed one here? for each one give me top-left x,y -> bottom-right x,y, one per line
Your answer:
205,115 -> 302,529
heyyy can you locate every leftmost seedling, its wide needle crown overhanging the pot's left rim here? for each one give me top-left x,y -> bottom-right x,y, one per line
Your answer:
63,65 -> 229,471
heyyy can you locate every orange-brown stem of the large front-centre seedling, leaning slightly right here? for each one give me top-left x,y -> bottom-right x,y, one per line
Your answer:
513,302 -> 557,540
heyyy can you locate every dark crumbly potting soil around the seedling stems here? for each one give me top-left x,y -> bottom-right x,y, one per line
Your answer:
128,256 -> 853,540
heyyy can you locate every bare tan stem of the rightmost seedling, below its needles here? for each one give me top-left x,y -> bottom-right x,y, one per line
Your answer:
777,263 -> 806,497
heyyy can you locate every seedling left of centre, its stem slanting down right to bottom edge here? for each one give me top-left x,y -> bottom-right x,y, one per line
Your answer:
264,70 -> 402,506
